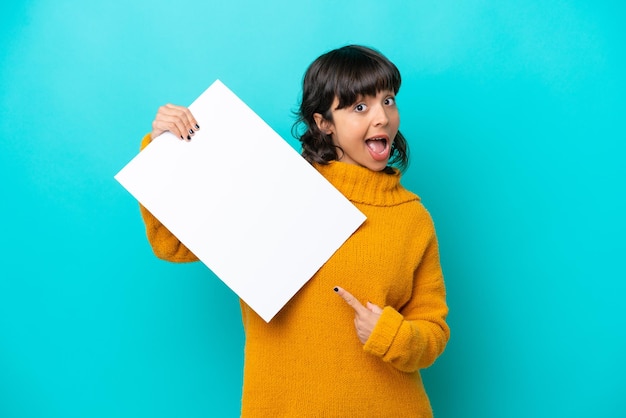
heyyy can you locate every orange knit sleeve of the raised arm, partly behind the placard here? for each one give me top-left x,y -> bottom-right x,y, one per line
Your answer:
139,134 -> 198,263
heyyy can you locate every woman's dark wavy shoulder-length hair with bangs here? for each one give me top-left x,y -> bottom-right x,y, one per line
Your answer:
292,45 -> 409,172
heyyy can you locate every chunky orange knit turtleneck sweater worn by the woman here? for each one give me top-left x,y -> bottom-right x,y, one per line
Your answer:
141,133 -> 450,418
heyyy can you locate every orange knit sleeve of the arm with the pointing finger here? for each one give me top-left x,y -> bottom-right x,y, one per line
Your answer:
363,229 -> 450,372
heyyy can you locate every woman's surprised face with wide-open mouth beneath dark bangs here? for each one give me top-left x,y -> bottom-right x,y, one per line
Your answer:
315,91 -> 400,171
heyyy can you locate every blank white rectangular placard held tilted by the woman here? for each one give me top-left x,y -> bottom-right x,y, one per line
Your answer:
115,80 -> 365,322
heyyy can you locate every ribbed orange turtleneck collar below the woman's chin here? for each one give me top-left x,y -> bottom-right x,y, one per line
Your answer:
313,161 -> 419,206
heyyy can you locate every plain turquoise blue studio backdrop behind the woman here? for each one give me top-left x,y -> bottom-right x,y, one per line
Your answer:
0,0 -> 626,418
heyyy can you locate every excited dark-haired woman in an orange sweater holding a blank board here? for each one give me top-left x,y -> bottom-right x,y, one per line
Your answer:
141,45 -> 450,418
